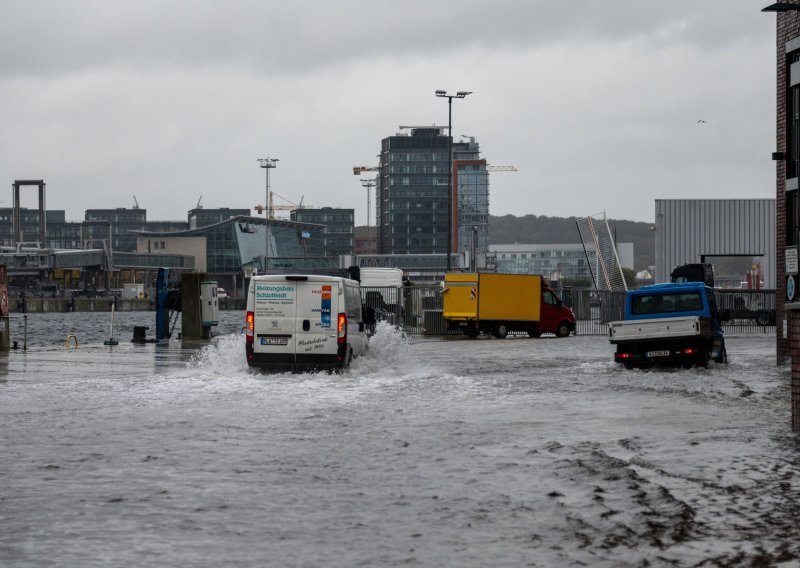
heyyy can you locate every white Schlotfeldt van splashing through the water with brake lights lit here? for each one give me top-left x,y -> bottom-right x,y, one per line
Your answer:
245,275 -> 367,372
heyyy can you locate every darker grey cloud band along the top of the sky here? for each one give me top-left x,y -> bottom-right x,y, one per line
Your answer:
0,0 -> 773,76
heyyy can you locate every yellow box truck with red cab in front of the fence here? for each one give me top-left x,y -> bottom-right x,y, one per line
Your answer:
442,272 -> 575,339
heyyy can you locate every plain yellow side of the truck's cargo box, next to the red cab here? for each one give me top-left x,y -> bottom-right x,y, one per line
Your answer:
478,273 -> 542,321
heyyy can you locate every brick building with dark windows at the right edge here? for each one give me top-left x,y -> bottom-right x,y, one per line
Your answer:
764,0 -> 800,432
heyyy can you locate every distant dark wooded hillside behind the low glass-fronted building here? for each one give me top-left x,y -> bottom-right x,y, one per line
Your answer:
489,215 -> 656,271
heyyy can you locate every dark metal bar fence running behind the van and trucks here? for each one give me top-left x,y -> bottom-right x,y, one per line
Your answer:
361,285 -> 776,335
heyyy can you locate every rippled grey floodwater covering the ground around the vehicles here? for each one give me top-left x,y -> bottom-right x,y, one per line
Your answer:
0,313 -> 800,567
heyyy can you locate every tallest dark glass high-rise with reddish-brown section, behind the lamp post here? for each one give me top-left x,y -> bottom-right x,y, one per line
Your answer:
376,126 -> 489,254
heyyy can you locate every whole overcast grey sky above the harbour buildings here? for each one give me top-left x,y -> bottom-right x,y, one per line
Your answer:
0,0 -> 775,224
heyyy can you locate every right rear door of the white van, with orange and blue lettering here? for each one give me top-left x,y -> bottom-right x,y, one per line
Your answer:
295,278 -> 343,363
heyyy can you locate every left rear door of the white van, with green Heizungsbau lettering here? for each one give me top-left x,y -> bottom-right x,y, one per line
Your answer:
253,280 -> 298,365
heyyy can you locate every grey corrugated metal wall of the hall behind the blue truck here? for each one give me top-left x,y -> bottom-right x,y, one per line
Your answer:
655,199 -> 777,288
